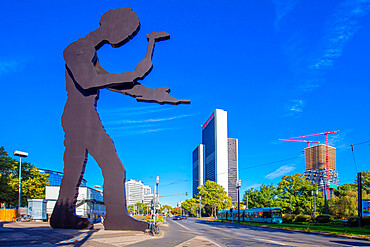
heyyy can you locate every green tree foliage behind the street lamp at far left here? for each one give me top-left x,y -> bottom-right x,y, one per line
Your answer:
0,147 -> 48,207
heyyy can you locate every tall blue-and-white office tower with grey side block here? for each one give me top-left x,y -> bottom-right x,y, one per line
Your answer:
193,109 -> 238,202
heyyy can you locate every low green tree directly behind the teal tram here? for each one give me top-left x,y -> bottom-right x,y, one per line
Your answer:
243,184 -> 280,208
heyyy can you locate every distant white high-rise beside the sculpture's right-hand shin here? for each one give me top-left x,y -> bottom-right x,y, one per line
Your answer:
125,179 -> 153,206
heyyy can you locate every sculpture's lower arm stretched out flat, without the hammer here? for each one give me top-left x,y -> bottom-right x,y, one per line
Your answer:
111,84 -> 190,105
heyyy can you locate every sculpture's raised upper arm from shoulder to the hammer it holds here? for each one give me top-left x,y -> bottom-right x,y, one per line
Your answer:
64,32 -> 169,89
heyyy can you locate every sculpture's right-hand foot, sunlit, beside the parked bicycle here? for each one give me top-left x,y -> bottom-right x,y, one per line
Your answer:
104,216 -> 149,232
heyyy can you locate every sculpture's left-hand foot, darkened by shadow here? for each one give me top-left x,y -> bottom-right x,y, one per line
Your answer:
50,210 -> 94,229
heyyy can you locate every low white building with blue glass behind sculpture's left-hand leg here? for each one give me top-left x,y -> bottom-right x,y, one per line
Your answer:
45,185 -> 105,221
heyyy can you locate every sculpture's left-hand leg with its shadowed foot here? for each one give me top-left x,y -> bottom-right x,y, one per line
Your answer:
50,144 -> 94,229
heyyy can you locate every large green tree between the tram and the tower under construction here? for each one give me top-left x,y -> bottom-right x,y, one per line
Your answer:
277,174 -> 323,214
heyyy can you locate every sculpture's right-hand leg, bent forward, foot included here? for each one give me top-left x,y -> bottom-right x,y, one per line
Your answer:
88,125 -> 148,231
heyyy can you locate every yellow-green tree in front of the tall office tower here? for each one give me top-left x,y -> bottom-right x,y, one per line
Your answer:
197,180 -> 231,216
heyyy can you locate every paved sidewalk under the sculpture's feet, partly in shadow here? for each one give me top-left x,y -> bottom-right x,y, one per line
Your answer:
0,222 -> 163,246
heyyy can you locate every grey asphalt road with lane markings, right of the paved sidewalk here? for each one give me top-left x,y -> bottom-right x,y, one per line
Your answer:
168,219 -> 370,247
